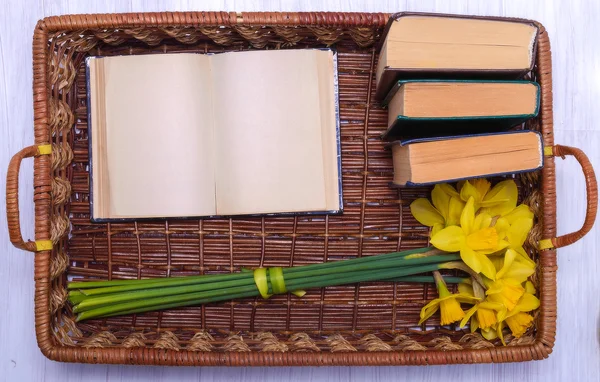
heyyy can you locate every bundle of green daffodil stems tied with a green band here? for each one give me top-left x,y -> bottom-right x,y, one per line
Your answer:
68,248 -> 460,321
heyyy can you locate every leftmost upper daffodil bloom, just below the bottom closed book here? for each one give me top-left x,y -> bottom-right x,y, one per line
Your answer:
410,184 -> 464,236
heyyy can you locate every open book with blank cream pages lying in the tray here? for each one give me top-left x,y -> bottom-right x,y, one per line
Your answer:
87,49 -> 342,221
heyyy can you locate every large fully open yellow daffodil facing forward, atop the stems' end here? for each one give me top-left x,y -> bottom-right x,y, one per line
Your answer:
431,197 -> 508,280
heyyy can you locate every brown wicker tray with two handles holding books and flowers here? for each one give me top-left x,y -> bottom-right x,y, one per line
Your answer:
7,12 -> 597,366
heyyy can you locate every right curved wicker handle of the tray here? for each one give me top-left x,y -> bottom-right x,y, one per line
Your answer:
539,145 -> 598,250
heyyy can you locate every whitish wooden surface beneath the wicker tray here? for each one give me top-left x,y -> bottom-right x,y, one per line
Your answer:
0,0 -> 600,382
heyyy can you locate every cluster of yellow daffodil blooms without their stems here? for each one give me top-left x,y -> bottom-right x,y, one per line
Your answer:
410,179 -> 540,343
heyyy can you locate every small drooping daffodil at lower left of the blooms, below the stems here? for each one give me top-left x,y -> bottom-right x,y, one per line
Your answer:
419,271 -> 479,325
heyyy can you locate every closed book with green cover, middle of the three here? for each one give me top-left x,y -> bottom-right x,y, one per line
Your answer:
384,80 -> 540,140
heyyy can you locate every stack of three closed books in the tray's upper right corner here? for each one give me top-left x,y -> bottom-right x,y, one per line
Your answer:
376,14 -> 543,186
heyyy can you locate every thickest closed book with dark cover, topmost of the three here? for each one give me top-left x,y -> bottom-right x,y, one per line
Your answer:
375,13 -> 538,100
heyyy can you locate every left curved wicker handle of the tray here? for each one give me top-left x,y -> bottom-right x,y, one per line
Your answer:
6,145 -> 52,252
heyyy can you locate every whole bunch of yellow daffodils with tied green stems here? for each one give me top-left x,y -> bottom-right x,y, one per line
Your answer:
68,179 -> 539,342
